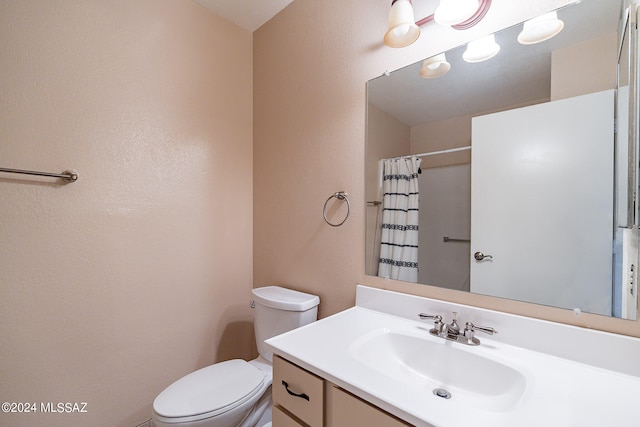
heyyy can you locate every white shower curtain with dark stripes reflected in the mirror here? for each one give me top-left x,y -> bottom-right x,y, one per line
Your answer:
378,157 -> 421,283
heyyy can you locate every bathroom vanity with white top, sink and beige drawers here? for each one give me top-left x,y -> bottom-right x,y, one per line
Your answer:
266,285 -> 640,427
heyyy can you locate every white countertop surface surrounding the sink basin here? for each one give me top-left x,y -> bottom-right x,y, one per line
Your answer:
266,288 -> 640,427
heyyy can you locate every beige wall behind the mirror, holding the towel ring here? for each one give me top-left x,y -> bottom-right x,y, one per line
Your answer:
254,0 -> 640,335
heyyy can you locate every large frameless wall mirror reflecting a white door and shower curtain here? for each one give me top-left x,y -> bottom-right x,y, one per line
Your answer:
365,0 -> 638,319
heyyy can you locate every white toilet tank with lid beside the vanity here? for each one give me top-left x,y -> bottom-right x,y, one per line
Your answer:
252,286 -> 320,362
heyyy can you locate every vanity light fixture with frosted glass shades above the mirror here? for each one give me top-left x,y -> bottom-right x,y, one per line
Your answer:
384,0 -> 491,47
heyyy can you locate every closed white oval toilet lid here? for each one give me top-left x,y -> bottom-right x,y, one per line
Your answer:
153,359 -> 266,417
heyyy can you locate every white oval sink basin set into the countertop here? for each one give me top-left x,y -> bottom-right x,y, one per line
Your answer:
349,329 -> 527,411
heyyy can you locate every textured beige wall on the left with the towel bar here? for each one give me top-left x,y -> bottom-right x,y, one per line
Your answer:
0,0 -> 255,427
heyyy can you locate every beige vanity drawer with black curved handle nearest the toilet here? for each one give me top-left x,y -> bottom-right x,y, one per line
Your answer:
272,356 -> 324,427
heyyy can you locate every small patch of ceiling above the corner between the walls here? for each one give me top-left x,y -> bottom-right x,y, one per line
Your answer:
195,0 -> 293,32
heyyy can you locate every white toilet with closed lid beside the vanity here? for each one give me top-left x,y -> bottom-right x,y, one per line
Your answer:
152,286 -> 320,427
